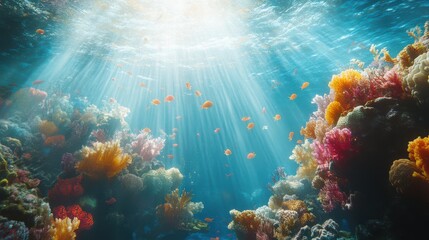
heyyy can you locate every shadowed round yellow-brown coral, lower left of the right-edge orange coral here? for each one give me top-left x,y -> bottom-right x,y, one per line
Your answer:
389,159 -> 421,193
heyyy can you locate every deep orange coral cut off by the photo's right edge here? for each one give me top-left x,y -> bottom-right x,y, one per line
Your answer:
408,137 -> 429,180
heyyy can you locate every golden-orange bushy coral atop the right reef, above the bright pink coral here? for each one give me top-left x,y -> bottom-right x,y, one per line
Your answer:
329,69 -> 365,110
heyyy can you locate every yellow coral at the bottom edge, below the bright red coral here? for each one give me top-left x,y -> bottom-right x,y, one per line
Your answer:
49,217 -> 80,240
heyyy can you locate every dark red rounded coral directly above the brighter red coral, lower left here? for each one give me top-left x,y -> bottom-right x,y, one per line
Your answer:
48,175 -> 84,203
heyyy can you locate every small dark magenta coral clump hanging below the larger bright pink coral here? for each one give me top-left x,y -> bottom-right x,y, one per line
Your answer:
319,179 -> 347,212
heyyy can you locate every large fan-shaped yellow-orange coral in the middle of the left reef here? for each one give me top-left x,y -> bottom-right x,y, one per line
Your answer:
76,142 -> 131,179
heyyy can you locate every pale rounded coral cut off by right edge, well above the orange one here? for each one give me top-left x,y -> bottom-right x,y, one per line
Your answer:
402,53 -> 429,104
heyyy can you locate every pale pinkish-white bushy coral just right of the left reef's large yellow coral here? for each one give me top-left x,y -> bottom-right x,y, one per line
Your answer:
131,131 -> 165,162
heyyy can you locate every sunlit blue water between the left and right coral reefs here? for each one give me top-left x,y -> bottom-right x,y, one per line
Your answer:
0,0 -> 429,239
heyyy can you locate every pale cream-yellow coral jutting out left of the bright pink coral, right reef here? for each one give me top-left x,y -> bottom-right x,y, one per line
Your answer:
289,139 -> 317,182
